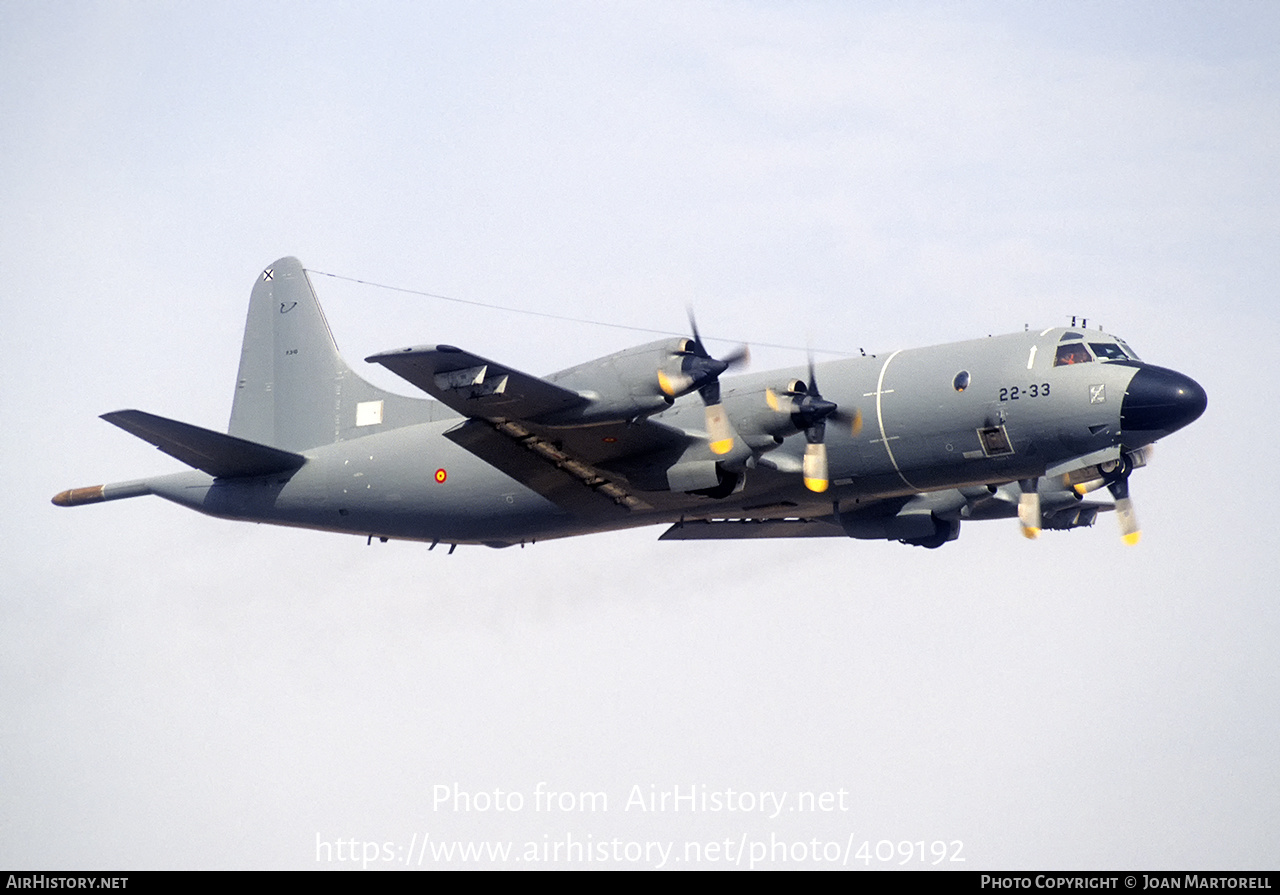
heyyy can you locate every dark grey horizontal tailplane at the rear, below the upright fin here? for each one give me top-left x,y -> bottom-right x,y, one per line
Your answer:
102,410 -> 307,479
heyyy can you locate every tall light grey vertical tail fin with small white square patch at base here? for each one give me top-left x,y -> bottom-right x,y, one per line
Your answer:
227,257 -> 426,451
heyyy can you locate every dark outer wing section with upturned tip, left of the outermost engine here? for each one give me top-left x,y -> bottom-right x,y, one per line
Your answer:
365,344 -> 588,421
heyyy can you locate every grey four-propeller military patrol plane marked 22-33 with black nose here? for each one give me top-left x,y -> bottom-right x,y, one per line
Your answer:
54,257 -> 1207,553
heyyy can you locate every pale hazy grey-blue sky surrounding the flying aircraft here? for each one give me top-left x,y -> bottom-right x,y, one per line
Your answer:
0,3 -> 1280,869
